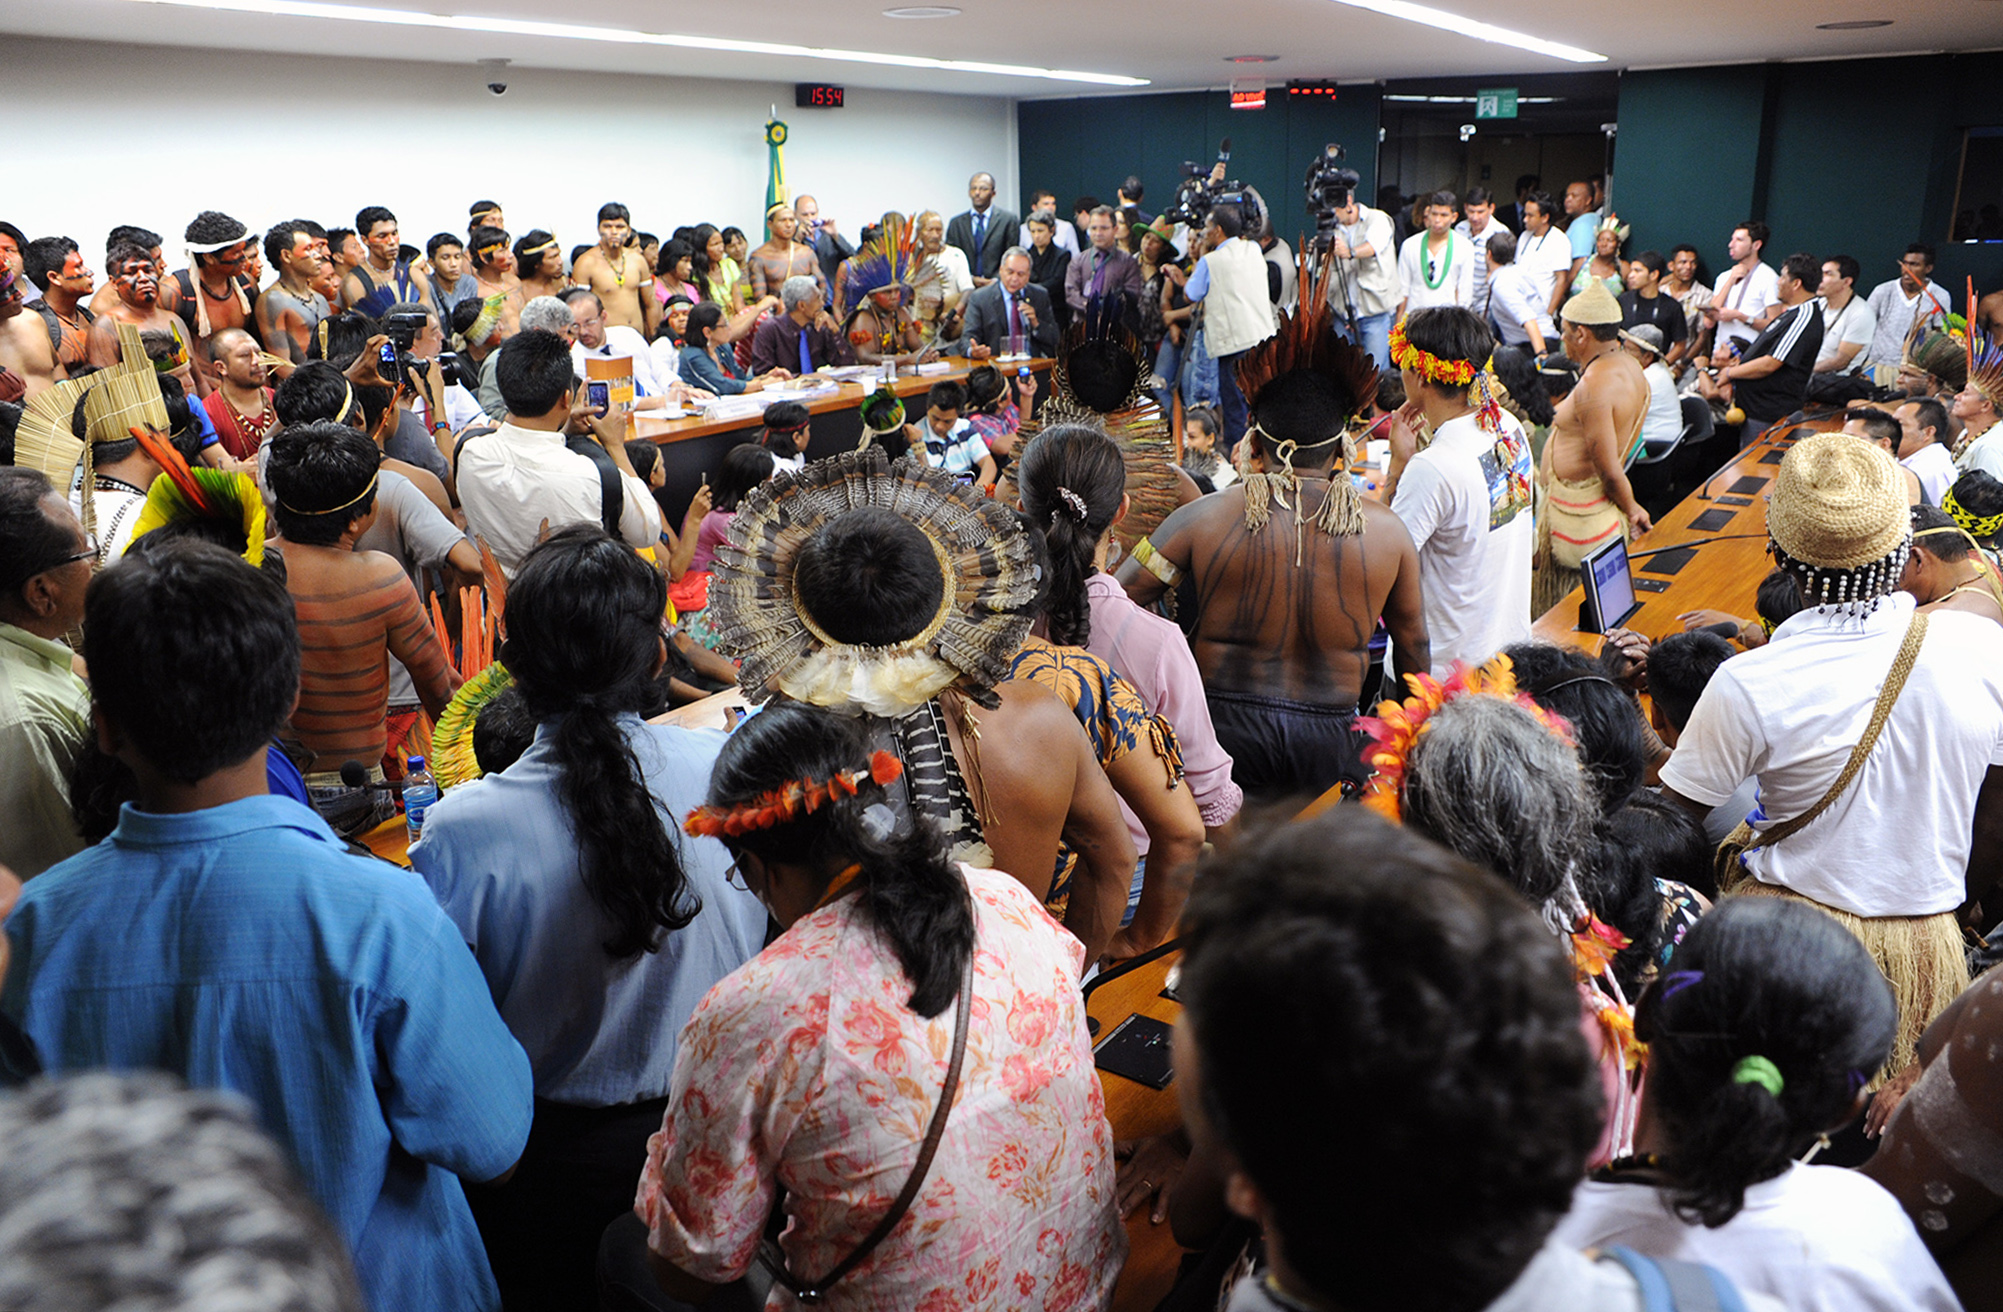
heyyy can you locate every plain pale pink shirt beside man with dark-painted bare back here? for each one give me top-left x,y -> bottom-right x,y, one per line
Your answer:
1086,573 -> 1246,837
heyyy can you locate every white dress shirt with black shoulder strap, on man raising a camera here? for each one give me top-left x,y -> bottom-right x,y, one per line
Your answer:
459,423 -> 661,579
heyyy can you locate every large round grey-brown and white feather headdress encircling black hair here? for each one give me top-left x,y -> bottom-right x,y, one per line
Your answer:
707,447 -> 1038,715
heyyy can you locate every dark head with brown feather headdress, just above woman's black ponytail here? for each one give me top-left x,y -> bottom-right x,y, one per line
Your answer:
1022,294 -> 1182,551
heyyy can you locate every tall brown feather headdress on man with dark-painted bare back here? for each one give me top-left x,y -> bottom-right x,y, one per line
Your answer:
1238,250 -> 1376,548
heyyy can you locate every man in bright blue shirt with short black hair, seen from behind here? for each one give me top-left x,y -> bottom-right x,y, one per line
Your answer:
0,541 -> 531,1312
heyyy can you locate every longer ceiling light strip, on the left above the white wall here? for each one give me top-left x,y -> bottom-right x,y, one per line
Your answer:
113,0 -> 1148,86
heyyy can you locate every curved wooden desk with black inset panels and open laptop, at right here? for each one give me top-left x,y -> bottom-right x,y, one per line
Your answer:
1530,421 -> 1841,651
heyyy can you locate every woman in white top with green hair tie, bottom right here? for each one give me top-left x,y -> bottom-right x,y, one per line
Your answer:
1556,897 -> 1961,1312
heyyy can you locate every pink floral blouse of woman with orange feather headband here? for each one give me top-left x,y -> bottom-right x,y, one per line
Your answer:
633,867 -> 1126,1312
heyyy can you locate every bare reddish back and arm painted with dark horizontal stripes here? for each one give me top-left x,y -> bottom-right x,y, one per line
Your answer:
286,545 -> 459,773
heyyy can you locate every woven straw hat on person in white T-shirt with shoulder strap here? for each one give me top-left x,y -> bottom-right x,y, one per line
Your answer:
1767,433 -> 1911,569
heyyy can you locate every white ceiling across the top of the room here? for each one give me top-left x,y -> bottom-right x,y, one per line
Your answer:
0,0 -> 2003,96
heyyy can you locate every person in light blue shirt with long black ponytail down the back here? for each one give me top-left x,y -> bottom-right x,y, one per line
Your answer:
411,525 -> 765,1306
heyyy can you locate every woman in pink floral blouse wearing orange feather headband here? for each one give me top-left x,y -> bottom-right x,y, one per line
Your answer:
635,703 -> 1126,1312
